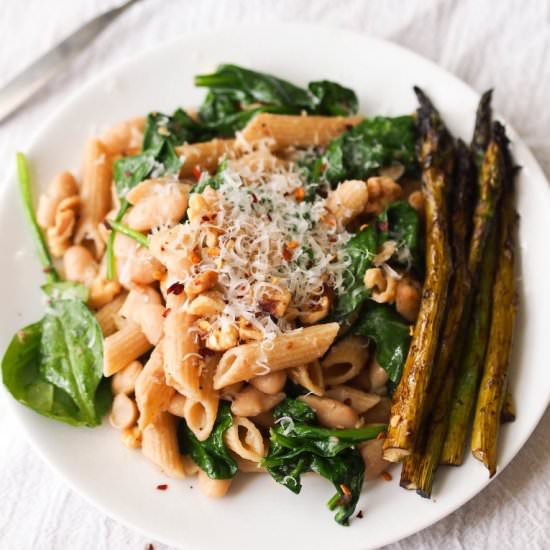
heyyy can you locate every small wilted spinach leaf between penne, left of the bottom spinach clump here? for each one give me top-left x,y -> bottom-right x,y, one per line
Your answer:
180,402 -> 237,479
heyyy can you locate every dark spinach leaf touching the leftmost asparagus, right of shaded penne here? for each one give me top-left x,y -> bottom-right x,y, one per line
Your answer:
354,300 -> 411,384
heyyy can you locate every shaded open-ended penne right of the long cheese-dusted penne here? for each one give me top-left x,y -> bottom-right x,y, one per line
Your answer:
321,336 -> 369,386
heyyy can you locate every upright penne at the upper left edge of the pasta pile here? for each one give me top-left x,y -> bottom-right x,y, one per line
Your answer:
75,139 -> 112,258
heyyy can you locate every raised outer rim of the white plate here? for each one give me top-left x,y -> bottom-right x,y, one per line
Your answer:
0,20 -> 550,550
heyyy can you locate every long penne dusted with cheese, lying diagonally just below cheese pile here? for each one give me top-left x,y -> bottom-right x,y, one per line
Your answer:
214,323 -> 339,389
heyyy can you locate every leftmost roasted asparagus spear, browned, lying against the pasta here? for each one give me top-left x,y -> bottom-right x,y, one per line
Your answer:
384,87 -> 454,462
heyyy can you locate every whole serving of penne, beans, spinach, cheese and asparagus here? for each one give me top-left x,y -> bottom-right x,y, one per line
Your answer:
2,65 -> 517,525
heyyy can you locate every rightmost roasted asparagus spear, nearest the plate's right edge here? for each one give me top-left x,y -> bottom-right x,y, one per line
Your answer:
472,161 -> 518,477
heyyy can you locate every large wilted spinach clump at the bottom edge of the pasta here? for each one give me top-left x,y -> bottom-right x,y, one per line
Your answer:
262,398 -> 385,525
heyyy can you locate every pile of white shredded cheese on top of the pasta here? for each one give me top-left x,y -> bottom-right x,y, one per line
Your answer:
167,157 -> 350,340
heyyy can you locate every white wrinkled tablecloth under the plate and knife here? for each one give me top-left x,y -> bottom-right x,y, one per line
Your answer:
0,0 -> 550,550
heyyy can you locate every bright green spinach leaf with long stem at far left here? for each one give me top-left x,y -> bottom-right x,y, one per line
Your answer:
2,153 -> 110,426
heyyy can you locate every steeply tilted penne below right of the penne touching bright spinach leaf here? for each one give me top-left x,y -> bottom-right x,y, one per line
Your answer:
135,342 -> 176,430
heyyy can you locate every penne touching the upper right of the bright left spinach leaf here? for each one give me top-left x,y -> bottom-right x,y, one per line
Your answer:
103,321 -> 153,376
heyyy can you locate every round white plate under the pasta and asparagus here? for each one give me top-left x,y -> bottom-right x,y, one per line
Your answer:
0,24 -> 550,550
